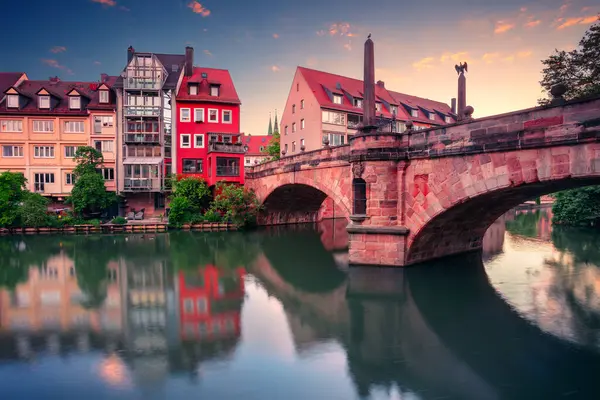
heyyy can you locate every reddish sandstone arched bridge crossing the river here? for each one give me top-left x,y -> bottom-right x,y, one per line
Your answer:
246,98 -> 600,266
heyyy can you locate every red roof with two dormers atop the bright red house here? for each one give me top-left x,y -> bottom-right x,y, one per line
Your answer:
177,67 -> 241,104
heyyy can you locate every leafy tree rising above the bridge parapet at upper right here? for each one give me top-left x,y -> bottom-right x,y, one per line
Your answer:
538,16 -> 600,104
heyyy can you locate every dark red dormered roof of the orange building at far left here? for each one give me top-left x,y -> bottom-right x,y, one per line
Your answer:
0,76 -> 117,115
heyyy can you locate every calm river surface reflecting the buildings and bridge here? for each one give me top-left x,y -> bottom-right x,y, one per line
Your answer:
0,210 -> 600,400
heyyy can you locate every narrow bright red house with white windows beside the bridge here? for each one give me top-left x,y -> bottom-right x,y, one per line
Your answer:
175,67 -> 244,186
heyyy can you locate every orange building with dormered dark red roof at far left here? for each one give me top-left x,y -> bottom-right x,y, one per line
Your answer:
0,73 -> 118,200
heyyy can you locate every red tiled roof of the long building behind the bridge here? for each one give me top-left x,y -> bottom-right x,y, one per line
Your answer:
298,67 -> 451,124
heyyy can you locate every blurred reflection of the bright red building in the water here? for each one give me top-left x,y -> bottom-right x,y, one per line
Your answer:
178,265 -> 244,340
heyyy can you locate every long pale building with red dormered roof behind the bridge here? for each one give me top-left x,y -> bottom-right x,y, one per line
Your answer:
280,67 -> 456,155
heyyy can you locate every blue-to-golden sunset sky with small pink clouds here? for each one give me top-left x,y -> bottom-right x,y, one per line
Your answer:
0,0 -> 600,135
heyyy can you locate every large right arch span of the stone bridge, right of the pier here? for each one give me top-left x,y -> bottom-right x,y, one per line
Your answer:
406,143 -> 600,264
